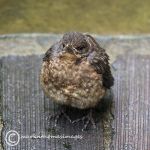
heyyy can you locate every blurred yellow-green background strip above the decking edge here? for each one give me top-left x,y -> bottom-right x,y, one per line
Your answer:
0,0 -> 150,35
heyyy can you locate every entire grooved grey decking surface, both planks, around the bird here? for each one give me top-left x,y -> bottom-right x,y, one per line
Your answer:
0,55 -> 150,150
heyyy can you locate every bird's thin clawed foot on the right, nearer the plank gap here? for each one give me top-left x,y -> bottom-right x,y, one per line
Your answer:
72,110 -> 96,131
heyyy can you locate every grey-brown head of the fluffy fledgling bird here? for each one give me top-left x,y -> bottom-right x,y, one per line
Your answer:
43,32 -> 100,62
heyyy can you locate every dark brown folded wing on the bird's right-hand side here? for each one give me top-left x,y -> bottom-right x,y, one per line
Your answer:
86,35 -> 114,89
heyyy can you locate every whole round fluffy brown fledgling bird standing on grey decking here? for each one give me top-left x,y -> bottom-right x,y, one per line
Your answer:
40,32 -> 114,130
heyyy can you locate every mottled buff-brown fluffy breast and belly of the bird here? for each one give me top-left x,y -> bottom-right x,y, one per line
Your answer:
40,57 -> 106,109
